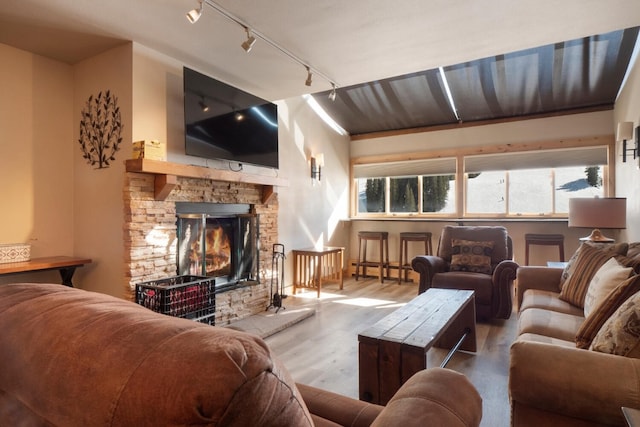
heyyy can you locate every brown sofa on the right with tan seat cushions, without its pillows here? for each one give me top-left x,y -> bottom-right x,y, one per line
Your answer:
509,243 -> 640,426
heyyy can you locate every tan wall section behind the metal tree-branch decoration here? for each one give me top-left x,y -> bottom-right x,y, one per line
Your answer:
72,44 -> 132,297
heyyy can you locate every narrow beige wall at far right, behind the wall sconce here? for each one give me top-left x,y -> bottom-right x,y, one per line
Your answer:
613,46 -> 640,241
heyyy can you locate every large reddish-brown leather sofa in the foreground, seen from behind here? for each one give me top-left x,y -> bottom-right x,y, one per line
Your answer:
0,283 -> 482,427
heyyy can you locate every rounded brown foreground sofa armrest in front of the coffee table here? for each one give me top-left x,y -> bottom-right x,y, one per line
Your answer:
371,368 -> 482,427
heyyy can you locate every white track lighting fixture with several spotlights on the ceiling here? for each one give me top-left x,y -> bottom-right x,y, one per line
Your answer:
182,0 -> 338,91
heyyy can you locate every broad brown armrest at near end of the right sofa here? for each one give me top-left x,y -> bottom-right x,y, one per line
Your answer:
509,340 -> 640,425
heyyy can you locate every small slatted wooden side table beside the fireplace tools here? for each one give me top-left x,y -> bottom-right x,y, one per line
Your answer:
291,246 -> 344,298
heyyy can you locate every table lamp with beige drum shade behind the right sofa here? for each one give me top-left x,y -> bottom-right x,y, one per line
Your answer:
569,197 -> 627,243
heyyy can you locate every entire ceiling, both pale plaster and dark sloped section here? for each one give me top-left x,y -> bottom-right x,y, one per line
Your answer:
0,0 -> 640,134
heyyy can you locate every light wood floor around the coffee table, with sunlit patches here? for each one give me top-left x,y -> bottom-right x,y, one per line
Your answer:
266,278 -> 516,427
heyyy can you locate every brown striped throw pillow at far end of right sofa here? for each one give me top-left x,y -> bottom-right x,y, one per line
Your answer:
560,245 -> 613,308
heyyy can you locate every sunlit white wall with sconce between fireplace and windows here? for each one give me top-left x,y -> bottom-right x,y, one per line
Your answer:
278,97 -> 350,274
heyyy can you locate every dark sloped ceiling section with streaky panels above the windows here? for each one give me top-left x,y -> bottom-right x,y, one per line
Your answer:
316,27 -> 638,135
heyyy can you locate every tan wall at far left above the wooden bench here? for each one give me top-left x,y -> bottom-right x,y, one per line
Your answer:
0,44 -> 77,283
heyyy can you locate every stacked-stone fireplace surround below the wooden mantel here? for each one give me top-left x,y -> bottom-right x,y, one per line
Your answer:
123,170 -> 278,325
